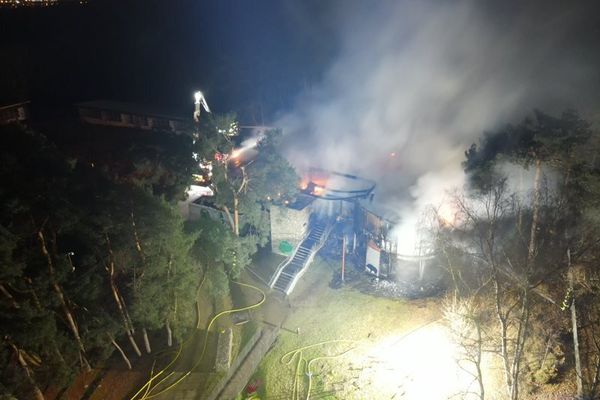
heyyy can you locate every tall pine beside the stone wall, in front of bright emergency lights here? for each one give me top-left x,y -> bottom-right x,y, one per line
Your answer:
192,115 -> 299,291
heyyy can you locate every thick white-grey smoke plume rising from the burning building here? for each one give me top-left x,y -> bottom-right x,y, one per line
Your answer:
277,1 -> 597,252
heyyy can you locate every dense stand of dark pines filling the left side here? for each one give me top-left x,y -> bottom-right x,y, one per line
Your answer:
0,126 -> 201,398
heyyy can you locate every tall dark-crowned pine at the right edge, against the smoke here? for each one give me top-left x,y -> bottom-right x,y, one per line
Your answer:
464,111 -> 597,397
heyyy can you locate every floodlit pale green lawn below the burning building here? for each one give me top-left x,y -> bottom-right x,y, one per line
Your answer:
248,259 -> 442,400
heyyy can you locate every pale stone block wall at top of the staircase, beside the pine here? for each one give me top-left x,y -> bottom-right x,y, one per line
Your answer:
271,205 -> 310,256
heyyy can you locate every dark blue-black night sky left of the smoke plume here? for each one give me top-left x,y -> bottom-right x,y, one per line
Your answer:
0,0 -> 335,122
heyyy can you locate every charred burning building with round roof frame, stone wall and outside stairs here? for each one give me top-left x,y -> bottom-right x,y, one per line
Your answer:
271,168 -> 398,293
